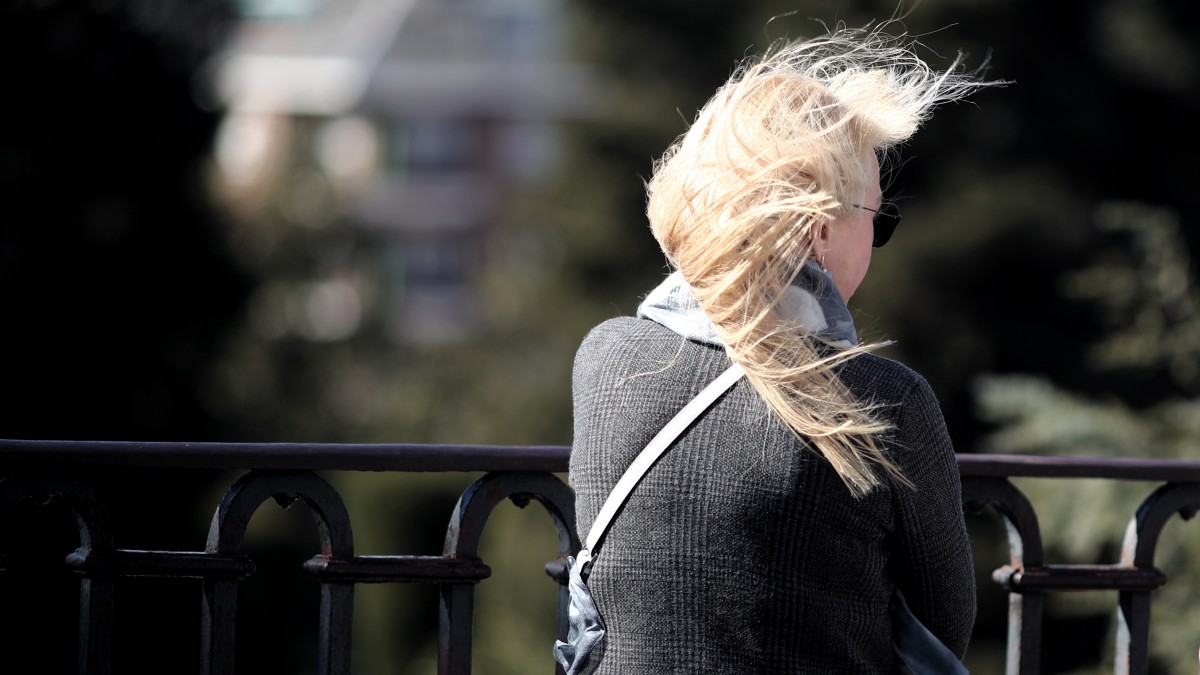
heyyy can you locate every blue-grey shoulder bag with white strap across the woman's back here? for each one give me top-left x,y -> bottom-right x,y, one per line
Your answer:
553,364 -> 967,675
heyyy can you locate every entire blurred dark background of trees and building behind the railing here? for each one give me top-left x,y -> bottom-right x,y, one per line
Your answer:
0,0 -> 1200,675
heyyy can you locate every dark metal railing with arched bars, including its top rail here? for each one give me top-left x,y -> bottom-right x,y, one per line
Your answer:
0,440 -> 1200,675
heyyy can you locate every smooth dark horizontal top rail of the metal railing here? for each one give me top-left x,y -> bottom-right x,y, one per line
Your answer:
0,438 -> 1200,483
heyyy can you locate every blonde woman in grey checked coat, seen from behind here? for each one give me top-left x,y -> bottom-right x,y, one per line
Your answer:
570,29 -> 998,674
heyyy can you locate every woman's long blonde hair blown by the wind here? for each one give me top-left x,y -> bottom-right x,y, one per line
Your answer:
647,28 -> 985,496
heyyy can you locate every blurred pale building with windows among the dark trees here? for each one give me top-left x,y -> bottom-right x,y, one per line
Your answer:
211,0 -> 593,342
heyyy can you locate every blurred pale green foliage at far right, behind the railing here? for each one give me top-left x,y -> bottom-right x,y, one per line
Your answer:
976,202 -> 1200,674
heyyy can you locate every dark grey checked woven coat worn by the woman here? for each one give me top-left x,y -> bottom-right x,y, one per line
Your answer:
570,317 -> 976,675
